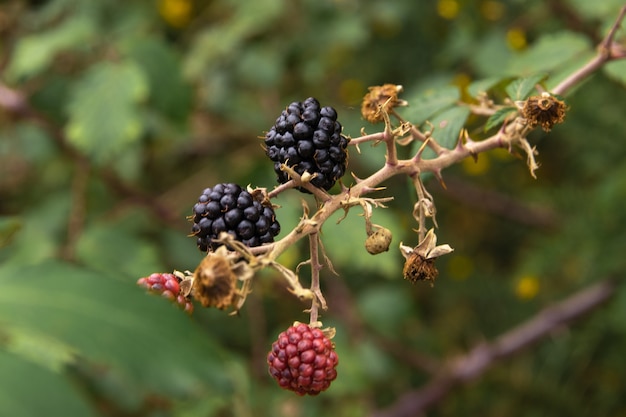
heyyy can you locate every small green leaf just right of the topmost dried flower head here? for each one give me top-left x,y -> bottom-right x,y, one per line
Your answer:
401,86 -> 461,125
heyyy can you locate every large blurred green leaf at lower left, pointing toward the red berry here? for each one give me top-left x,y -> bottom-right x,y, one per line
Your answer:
0,261 -> 229,396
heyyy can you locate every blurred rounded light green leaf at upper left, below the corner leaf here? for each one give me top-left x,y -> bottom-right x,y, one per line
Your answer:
65,62 -> 148,163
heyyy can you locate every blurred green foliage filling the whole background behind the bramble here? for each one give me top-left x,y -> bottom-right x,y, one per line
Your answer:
0,0 -> 626,417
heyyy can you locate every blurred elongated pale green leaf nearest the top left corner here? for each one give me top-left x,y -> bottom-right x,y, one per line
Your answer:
6,16 -> 95,82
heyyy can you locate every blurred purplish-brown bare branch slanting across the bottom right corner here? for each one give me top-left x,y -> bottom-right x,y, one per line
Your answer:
371,279 -> 617,417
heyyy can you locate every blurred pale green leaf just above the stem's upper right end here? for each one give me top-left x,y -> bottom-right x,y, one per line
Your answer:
508,32 -> 592,74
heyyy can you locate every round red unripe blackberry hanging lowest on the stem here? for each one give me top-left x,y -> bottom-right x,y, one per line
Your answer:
267,323 -> 339,395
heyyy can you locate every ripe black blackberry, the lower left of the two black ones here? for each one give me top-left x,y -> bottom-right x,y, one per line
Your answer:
191,183 -> 280,252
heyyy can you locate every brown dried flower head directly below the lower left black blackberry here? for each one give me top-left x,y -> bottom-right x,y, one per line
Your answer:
192,253 -> 238,310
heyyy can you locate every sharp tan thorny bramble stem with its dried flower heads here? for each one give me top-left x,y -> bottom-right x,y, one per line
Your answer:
183,7 -> 626,327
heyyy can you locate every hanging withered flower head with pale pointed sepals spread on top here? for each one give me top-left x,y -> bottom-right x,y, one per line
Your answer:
400,229 -> 454,285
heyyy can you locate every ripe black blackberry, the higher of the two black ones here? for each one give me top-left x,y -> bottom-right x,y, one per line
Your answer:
265,97 -> 348,192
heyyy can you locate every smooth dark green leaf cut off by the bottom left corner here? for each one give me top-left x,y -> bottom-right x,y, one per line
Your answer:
0,349 -> 97,417
